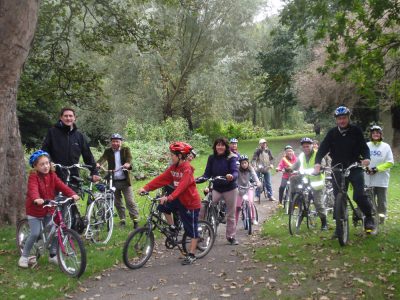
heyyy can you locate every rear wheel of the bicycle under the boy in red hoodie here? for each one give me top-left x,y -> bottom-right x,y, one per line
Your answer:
182,221 -> 215,258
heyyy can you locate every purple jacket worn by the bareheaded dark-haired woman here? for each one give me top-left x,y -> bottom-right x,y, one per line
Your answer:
202,154 -> 238,193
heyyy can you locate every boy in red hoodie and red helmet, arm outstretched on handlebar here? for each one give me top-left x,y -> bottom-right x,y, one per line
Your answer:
139,142 -> 201,265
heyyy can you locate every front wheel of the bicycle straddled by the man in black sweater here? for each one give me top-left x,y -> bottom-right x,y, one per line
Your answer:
335,193 -> 349,246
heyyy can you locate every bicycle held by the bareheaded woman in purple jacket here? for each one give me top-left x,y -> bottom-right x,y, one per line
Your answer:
196,176 -> 227,235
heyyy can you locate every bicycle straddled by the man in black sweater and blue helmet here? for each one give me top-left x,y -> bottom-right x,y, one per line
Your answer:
332,162 -> 377,246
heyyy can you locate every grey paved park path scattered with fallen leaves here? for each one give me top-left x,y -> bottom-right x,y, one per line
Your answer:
72,174 -> 280,300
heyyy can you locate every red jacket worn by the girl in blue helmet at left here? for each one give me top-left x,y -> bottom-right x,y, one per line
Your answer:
25,171 -> 76,218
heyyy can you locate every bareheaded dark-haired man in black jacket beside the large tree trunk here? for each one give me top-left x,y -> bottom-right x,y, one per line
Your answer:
42,107 -> 100,183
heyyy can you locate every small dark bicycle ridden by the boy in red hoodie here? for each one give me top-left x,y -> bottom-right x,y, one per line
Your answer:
123,193 -> 215,269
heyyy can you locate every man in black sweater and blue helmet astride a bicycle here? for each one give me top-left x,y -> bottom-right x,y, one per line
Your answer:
314,106 -> 375,230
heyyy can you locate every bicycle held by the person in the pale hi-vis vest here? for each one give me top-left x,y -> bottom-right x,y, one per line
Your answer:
289,173 -> 318,235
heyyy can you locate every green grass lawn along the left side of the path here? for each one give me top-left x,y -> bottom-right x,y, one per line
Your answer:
0,136 -> 310,299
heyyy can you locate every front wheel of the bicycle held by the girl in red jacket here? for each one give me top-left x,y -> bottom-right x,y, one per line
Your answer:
57,228 -> 86,277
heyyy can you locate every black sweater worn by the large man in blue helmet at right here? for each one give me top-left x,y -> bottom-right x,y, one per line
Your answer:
315,124 -> 370,168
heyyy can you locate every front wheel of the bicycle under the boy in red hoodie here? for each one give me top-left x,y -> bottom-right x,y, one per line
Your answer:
122,227 -> 154,269
